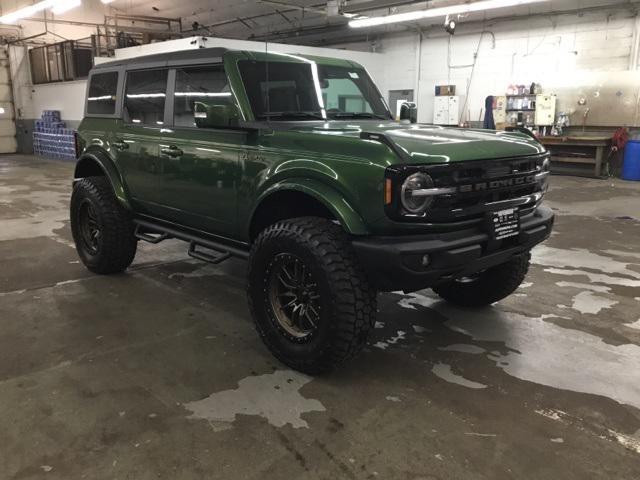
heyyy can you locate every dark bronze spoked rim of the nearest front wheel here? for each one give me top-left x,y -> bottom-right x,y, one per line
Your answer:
268,253 -> 321,341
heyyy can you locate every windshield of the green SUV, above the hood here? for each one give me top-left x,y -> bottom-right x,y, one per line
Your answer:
238,60 -> 391,120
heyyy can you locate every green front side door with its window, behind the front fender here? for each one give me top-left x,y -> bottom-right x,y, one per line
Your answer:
159,65 -> 247,236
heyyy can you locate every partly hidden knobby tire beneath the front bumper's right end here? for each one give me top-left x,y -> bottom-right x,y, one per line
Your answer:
433,252 -> 531,307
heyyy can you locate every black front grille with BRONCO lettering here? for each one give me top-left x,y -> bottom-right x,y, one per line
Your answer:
394,154 -> 546,224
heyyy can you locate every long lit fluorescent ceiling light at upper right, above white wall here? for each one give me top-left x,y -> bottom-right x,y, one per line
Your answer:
349,0 -> 547,28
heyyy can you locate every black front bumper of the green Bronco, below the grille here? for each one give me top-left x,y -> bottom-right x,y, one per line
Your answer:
352,207 -> 554,292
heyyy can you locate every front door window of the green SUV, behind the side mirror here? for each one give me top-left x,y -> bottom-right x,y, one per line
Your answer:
173,65 -> 234,127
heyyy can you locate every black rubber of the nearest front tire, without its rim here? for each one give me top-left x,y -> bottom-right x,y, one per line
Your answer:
247,217 -> 376,374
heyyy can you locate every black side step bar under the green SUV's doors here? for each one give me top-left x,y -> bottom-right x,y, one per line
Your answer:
134,219 -> 249,264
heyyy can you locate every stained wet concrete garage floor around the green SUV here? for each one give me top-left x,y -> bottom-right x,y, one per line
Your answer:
0,155 -> 640,480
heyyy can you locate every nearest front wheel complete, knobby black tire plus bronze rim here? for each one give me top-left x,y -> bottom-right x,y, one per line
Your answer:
247,217 -> 376,374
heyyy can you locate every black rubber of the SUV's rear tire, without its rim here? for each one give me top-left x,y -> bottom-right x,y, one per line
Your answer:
70,177 -> 138,274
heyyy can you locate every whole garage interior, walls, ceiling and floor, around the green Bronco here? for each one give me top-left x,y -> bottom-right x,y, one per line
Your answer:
0,0 -> 640,480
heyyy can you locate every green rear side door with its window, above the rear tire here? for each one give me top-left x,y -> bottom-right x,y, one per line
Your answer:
112,69 -> 168,215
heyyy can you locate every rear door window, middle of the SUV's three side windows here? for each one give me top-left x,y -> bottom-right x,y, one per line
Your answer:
124,69 -> 168,125
